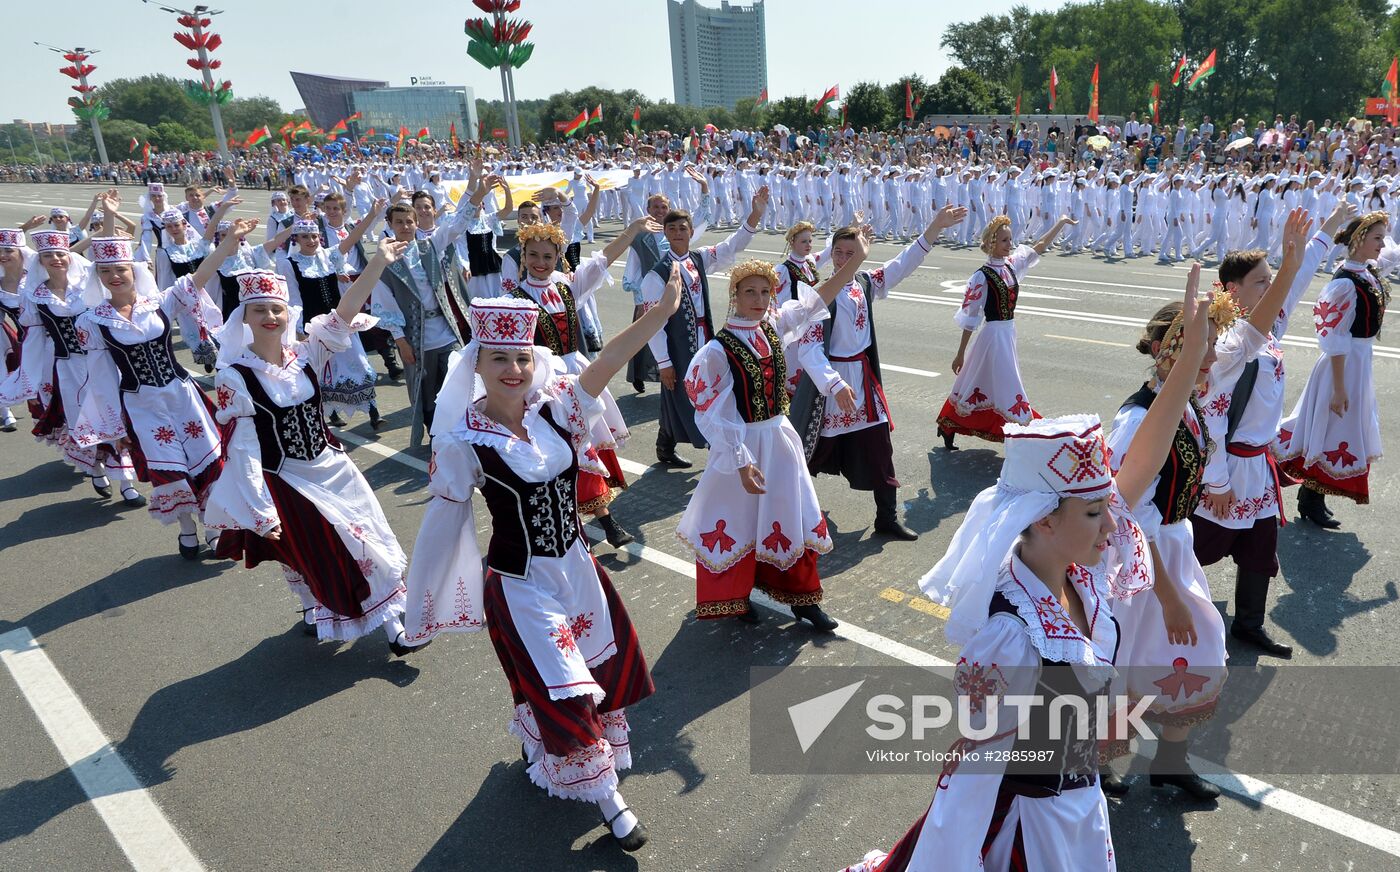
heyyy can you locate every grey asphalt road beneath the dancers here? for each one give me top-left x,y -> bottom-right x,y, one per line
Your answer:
0,185 -> 1400,872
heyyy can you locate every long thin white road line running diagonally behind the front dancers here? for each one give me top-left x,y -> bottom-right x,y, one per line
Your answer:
340,433 -> 1400,857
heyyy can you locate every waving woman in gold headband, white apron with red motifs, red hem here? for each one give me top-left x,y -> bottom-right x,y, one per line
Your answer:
676,249 -> 869,631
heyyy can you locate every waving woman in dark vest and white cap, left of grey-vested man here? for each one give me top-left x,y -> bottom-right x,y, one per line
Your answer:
277,211 -> 388,430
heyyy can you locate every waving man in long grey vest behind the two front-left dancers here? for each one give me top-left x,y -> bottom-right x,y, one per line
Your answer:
370,196 -> 476,446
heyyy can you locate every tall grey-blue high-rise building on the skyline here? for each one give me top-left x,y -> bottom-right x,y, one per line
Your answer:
666,0 -> 769,109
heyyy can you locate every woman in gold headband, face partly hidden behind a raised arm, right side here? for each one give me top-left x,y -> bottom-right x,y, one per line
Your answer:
1105,263 -> 1248,801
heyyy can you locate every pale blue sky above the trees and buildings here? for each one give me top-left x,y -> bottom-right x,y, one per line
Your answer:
0,0 -> 1061,122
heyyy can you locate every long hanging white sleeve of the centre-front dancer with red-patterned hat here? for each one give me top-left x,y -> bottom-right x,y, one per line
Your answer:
403,434 -> 486,645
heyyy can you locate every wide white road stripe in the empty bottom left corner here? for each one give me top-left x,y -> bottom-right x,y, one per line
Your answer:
0,627 -> 204,872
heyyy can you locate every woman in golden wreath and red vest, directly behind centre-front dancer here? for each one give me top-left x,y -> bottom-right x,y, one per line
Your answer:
507,218 -> 658,547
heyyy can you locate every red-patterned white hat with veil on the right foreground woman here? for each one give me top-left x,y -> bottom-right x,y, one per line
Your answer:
918,414 -> 1152,645
